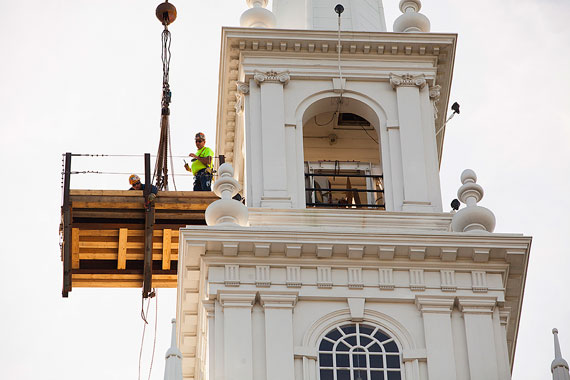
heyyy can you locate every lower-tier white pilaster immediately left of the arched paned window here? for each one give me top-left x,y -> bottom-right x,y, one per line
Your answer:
260,293 -> 297,380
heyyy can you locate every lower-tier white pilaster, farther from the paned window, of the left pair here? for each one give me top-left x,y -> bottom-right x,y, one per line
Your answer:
219,292 -> 256,380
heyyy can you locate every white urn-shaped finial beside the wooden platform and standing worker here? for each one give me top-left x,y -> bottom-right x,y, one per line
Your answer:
205,163 -> 249,226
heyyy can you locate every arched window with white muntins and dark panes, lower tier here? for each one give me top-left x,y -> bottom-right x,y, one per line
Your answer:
319,323 -> 402,380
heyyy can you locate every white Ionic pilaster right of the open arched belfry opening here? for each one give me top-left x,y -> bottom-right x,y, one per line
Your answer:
390,74 -> 433,211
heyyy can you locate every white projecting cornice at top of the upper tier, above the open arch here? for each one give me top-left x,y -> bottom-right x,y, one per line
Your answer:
216,27 -> 457,162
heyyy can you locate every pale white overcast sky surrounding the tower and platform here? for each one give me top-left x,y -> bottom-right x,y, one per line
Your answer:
0,0 -> 570,380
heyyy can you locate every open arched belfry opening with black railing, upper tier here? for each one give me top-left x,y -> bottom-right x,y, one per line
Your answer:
303,98 -> 384,210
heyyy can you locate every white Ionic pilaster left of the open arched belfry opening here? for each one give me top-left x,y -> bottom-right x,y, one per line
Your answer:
253,71 -> 295,208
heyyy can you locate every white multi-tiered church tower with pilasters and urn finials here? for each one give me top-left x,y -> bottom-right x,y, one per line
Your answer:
177,0 -> 531,380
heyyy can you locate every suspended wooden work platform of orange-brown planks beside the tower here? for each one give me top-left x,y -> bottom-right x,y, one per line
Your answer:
61,190 -> 219,297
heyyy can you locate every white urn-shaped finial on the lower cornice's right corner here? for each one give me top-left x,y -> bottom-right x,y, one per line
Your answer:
451,169 -> 495,232
